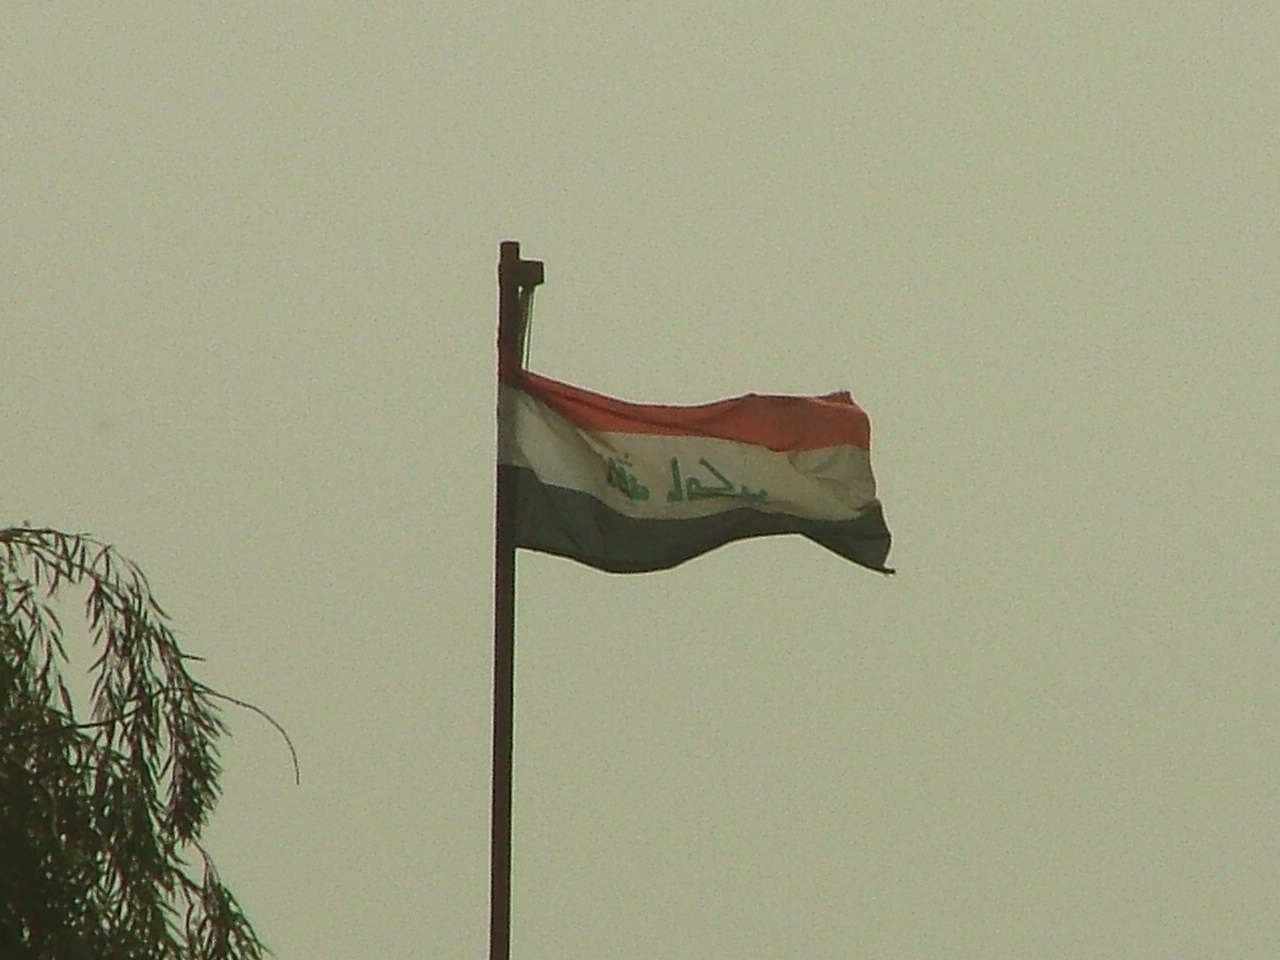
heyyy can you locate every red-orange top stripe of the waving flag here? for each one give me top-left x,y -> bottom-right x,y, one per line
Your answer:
502,365 -> 870,452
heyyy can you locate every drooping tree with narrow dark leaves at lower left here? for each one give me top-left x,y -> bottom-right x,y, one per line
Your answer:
0,526 -> 292,960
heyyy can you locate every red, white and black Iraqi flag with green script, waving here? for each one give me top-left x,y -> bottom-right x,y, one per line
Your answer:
498,364 -> 892,573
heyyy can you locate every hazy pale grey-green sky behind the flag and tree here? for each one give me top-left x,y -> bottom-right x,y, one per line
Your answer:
0,0 -> 1280,960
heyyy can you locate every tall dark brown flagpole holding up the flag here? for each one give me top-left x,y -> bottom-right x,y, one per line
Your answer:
489,241 -> 543,960
